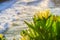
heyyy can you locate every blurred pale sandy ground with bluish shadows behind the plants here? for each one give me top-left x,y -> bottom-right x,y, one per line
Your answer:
0,0 -> 60,40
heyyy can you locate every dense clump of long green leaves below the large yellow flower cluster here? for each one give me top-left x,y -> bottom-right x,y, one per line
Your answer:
21,15 -> 60,40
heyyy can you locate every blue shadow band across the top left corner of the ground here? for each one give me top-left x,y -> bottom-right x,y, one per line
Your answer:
0,0 -> 17,12
